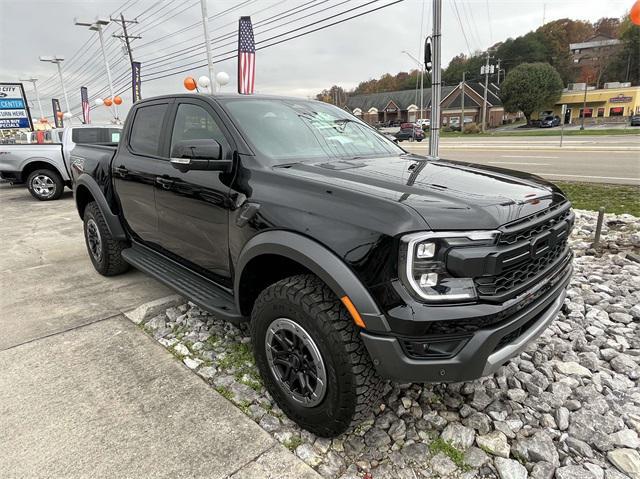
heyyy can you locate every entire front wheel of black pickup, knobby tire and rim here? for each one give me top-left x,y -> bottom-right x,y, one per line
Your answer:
251,275 -> 384,437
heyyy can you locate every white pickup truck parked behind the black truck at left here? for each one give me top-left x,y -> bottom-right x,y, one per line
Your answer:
0,125 -> 121,201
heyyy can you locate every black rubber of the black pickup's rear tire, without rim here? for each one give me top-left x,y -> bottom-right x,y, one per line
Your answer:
83,201 -> 129,276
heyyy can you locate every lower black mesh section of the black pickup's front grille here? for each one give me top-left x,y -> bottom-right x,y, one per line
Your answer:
474,240 -> 567,296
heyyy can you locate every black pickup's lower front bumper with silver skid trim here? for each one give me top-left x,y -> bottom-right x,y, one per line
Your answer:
361,265 -> 572,382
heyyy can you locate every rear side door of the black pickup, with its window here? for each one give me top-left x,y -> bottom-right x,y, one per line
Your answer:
111,99 -> 173,245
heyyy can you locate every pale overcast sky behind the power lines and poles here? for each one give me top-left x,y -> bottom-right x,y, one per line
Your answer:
0,0 -> 633,121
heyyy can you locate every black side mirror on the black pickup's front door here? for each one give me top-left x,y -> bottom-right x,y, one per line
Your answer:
170,139 -> 232,172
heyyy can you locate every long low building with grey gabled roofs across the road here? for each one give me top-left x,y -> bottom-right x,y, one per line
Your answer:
346,82 -> 518,128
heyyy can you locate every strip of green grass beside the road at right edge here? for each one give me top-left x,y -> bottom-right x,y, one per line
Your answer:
554,181 -> 640,216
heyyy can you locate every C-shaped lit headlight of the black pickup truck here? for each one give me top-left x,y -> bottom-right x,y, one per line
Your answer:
398,231 -> 500,302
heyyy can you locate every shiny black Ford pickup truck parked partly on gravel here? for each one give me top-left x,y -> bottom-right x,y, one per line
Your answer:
73,95 -> 574,436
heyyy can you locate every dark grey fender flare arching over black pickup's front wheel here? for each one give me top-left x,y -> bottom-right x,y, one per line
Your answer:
234,230 -> 389,331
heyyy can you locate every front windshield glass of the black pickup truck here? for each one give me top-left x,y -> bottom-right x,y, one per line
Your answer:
225,99 -> 404,163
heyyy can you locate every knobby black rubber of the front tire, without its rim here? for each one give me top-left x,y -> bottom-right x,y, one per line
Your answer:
250,275 -> 385,437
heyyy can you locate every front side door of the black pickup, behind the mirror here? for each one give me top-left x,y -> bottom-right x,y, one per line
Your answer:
156,98 -> 233,285
